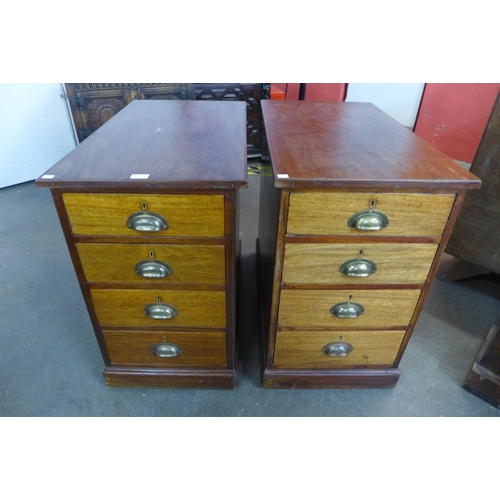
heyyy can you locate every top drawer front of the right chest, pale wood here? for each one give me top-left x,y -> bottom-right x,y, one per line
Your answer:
287,192 -> 455,237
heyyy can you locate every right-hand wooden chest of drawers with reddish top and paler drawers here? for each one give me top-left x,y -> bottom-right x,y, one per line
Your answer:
257,101 -> 480,388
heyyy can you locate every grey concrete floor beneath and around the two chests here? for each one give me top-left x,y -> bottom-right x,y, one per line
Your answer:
0,175 -> 500,417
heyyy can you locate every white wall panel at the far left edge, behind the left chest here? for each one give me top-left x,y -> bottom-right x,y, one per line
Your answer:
0,83 -> 75,188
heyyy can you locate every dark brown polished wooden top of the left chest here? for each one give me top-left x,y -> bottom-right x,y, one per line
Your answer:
36,100 -> 248,189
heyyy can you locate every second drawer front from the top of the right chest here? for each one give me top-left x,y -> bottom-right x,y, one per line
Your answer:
282,243 -> 438,285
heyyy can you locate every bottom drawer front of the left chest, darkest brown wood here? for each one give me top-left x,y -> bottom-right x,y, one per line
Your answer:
103,330 -> 226,368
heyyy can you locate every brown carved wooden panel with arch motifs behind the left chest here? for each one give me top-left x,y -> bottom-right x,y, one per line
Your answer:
65,83 -> 194,142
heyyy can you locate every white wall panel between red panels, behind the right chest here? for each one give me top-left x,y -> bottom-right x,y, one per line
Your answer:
346,83 -> 425,130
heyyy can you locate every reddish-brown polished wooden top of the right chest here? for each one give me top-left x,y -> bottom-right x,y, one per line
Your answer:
261,101 -> 480,190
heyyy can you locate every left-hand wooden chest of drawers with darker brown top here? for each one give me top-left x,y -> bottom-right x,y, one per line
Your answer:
37,101 -> 247,388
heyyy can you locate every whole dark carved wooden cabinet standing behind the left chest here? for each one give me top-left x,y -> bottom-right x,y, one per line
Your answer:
65,83 -> 271,157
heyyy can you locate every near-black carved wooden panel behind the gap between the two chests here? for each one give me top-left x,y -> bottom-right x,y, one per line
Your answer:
194,83 -> 271,156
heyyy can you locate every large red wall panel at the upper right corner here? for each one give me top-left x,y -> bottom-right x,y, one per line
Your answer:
415,83 -> 500,163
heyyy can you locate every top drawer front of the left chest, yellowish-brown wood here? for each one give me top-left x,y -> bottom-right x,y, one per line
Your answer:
63,193 -> 224,237
